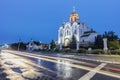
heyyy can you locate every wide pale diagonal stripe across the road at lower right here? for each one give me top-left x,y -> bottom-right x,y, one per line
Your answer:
79,63 -> 107,80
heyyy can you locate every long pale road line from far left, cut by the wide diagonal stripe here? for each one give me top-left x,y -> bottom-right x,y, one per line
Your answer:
4,50 -> 120,78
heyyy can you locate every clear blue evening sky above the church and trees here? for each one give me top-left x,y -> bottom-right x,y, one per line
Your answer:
0,0 -> 120,44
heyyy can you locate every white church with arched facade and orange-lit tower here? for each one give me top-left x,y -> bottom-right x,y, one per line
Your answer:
58,8 -> 98,46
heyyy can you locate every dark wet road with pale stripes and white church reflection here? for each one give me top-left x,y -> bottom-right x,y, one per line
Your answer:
3,52 -> 120,80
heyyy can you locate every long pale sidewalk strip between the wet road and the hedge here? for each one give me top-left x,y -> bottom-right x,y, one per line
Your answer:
22,52 -> 120,64
